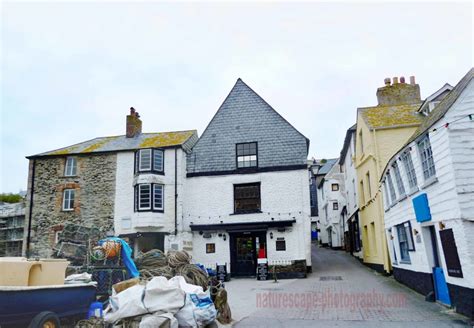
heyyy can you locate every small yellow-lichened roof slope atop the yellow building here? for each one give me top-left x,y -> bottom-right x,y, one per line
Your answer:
358,103 -> 423,129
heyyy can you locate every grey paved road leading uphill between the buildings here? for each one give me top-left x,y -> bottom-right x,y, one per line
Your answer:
230,246 -> 470,328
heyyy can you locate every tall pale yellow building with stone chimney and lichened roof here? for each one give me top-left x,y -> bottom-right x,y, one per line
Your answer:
355,77 -> 422,272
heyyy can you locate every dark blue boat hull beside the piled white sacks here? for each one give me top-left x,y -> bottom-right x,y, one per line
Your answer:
0,284 -> 96,326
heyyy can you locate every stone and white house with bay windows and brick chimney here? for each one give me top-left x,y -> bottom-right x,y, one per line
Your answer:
23,108 -> 197,257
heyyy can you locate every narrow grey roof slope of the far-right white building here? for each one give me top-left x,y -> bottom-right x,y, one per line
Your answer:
406,68 -> 474,145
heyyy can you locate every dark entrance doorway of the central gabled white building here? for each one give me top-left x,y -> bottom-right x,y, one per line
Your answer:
229,231 -> 266,277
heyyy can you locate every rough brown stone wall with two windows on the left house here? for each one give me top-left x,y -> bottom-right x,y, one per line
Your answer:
25,154 -> 116,257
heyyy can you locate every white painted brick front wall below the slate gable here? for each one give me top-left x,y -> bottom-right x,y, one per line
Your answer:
183,169 -> 311,265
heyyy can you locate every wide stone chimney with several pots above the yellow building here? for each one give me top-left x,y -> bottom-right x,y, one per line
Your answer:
377,76 -> 421,106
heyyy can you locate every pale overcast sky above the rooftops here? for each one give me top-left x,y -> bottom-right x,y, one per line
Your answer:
0,2 -> 473,192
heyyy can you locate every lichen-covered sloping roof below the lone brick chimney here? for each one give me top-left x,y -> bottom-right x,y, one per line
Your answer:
28,130 -> 197,158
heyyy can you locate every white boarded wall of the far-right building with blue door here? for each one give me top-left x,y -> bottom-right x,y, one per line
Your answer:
382,81 -> 474,288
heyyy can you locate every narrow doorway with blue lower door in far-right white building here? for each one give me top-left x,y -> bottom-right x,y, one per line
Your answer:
423,226 -> 451,306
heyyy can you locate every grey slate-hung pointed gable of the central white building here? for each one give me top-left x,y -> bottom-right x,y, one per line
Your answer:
187,79 -> 309,176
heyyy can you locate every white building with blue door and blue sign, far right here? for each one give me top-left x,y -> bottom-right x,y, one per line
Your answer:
380,69 -> 474,318
